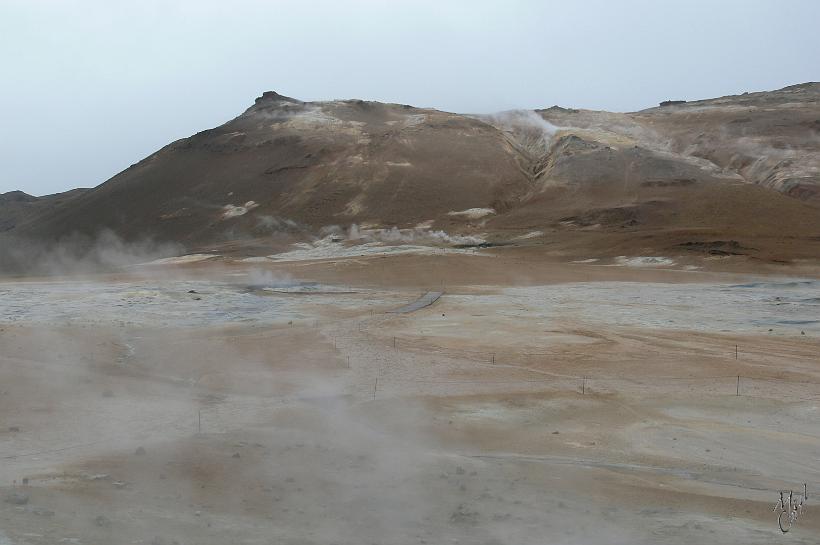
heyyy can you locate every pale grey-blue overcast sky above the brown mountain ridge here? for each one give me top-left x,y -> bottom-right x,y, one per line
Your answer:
0,0 -> 820,195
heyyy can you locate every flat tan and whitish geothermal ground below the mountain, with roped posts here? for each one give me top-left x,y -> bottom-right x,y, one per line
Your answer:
0,250 -> 820,545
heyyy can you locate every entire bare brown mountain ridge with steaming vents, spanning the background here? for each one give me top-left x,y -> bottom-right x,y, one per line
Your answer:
0,83 -> 820,260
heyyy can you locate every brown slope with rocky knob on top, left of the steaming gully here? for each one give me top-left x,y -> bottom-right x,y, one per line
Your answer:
12,92 -> 526,243
